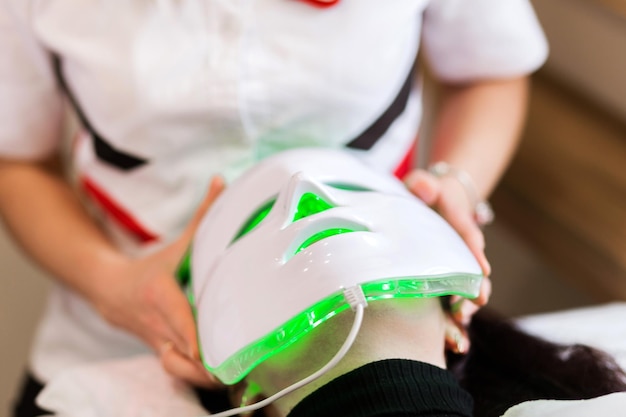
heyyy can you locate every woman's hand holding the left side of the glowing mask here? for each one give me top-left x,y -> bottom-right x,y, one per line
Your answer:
90,177 -> 224,387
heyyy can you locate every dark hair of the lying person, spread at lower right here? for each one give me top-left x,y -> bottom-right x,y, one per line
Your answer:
448,309 -> 626,417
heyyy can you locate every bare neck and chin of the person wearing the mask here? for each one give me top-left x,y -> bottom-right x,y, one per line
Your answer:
250,298 -> 445,416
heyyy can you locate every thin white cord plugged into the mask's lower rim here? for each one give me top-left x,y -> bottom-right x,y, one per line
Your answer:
206,285 -> 367,417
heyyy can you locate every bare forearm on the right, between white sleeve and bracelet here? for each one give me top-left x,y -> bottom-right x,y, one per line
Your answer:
429,77 -> 528,198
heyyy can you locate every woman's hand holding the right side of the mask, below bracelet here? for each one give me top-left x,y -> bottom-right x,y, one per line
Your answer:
404,170 -> 491,325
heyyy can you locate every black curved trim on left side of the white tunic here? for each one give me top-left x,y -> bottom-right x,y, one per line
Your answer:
52,55 -> 148,171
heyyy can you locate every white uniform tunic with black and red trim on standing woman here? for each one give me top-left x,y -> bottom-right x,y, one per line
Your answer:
0,0 -> 547,382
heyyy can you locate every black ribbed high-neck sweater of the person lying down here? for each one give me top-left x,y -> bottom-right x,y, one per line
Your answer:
287,359 -> 473,417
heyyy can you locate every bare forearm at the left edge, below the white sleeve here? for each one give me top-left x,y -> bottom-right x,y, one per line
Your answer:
0,156 -> 122,299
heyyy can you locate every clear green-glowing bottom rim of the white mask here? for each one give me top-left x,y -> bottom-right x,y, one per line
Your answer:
204,274 -> 482,384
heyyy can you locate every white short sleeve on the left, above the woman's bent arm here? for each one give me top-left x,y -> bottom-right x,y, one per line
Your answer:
0,0 -> 63,159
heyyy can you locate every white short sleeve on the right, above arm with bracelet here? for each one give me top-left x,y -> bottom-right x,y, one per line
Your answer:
422,0 -> 548,82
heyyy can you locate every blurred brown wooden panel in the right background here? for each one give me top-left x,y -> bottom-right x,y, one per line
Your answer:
492,73 -> 626,301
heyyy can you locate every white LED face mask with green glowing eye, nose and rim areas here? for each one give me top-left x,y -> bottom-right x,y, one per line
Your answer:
183,149 -> 482,384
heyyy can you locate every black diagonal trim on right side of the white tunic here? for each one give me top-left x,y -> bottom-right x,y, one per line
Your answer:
346,65 -> 415,151
